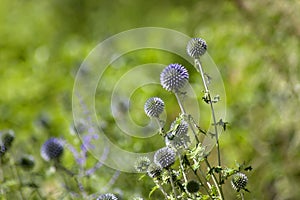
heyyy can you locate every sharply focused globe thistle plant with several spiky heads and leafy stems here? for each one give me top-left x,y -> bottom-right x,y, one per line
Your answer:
135,38 -> 252,200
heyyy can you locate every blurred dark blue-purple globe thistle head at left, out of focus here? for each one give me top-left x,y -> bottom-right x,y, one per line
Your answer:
41,138 -> 64,161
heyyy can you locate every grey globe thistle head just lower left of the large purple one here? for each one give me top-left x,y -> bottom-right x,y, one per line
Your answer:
144,97 -> 165,117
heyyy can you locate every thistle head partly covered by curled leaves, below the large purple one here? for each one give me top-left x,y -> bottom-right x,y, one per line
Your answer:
165,120 -> 190,149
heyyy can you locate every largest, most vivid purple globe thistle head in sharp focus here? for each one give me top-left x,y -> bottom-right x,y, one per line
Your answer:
160,64 -> 189,93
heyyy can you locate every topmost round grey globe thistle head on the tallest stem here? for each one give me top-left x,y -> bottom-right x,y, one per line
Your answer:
186,38 -> 207,59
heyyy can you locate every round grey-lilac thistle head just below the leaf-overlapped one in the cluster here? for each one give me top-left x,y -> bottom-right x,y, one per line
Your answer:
154,147 -> 176,168
